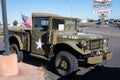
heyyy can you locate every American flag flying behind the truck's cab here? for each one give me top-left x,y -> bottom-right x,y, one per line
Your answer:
22,15 -> 32,28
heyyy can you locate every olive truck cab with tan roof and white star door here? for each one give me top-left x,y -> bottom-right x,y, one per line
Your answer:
31,13 -> 78,57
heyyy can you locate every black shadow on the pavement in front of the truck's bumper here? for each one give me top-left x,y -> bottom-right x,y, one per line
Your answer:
58,67 -> 120,80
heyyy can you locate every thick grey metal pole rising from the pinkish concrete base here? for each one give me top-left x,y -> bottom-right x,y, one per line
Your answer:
1,0 -> 10,55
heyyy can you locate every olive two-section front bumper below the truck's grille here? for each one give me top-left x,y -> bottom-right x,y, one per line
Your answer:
87,52 -> 112,64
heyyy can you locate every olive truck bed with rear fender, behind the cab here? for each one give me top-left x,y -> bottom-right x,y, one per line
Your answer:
8,29 -> 32,51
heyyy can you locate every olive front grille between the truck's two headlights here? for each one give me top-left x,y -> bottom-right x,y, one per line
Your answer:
90,39 -> 102,50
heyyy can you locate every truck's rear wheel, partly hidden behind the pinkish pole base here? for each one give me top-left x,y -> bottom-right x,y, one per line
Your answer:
10,44 -> 23,62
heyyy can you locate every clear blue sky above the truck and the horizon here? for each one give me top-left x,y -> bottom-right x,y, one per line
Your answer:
0,0 -> 120,23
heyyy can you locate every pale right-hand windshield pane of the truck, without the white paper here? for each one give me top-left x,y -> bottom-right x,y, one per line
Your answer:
66,19 -> 76,30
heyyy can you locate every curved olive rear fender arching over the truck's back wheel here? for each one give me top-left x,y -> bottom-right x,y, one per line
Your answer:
9,35 -> 23,50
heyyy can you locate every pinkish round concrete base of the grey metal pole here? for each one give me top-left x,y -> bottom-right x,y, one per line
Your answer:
0,54 -> 18,76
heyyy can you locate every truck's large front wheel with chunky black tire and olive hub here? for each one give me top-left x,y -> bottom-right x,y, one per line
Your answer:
55,51 -> 78,76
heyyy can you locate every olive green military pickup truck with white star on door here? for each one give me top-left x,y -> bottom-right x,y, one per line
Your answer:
9,13 -> 112,76
